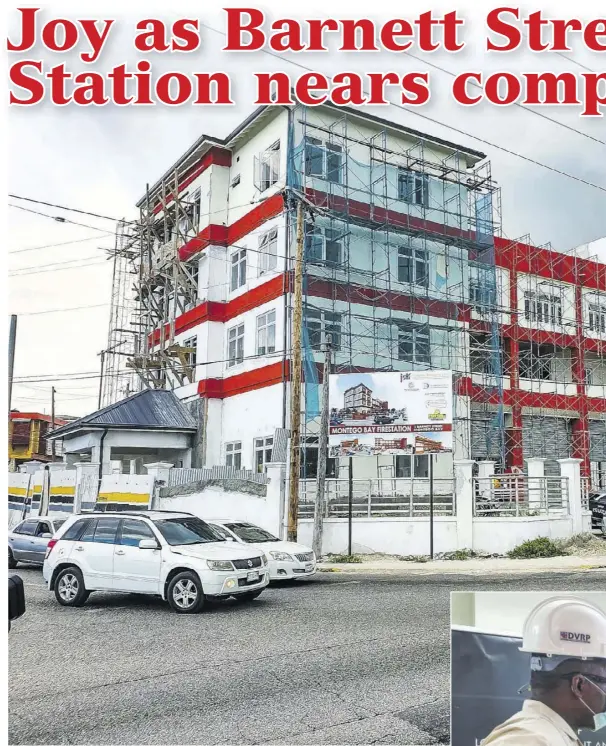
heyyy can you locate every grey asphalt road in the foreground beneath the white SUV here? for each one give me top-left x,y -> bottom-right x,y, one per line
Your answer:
9,569 -> 606,744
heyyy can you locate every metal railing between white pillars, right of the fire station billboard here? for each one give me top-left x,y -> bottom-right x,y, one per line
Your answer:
473,474 -> 569,518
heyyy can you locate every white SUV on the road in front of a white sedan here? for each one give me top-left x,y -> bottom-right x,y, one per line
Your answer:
42,511 -> 269,614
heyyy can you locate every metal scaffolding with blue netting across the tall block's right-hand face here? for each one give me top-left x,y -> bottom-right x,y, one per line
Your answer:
289,108 -> 506,476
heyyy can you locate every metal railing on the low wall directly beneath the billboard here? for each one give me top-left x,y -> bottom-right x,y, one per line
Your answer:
299,478 -> 456,518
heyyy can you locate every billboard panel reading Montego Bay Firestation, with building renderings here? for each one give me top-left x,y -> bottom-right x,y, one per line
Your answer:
329,370 -> 452,458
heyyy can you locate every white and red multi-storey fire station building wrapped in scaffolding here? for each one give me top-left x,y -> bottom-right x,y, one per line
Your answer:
103,105 -> 606,482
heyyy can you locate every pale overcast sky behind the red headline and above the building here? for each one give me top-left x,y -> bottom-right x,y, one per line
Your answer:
8,0 -> 606,415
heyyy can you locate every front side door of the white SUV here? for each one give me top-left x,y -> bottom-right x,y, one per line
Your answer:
114,518 -> 162,593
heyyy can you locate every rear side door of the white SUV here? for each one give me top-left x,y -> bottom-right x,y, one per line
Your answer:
70,516 -> 120,591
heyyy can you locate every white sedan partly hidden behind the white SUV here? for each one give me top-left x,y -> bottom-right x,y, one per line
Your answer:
208,519 -> 316,580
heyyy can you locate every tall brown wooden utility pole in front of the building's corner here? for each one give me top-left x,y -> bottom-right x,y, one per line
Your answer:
288,200 -> 304,541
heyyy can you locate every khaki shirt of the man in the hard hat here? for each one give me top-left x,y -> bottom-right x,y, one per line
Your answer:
481,699 -> 583,746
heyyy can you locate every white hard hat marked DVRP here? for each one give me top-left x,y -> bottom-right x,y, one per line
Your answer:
520,596 -> 606,671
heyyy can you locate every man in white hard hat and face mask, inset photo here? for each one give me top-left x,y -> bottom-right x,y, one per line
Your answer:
482,597 -> 606,746
